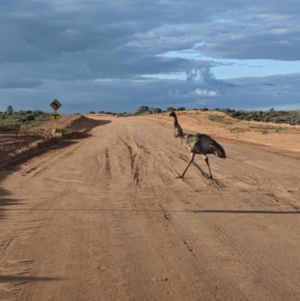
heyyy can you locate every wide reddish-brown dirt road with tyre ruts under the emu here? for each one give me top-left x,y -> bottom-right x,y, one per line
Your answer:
0,117 -> 300,301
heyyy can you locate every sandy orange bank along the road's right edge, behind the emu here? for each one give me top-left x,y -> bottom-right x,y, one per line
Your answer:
147,111 -> 300,151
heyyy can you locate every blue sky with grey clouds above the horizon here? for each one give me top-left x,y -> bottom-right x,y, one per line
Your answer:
0,0 -> 300,114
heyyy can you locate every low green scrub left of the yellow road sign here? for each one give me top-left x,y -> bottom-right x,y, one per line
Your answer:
0,106 -> 49,131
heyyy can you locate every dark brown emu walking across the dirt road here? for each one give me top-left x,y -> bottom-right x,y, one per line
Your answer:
169,112 -> 226,179
